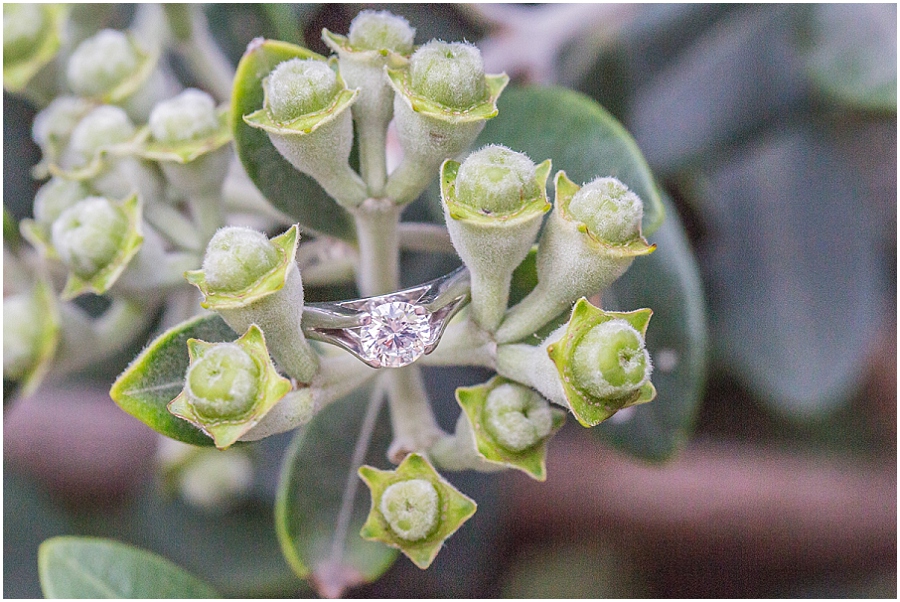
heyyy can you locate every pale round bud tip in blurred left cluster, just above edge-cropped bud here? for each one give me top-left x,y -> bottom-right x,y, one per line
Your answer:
51,197 -> 129,280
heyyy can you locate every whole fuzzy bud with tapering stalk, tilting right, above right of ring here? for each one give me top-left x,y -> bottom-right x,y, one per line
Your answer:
496,171 -> 656,343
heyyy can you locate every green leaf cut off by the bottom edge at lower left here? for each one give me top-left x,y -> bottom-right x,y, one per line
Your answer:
38,537 -> 219,598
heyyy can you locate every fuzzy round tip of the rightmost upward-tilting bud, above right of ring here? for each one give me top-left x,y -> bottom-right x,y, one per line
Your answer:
569,178 -> 644,243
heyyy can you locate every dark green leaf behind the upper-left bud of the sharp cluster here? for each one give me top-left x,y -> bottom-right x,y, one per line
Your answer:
231,39 -> 356,240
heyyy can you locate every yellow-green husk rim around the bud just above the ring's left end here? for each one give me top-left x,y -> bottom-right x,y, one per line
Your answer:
184,224 -> 300,311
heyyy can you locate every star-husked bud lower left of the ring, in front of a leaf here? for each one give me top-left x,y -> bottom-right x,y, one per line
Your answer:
167,324 -> 291,449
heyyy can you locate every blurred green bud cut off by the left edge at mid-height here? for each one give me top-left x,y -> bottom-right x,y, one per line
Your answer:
3,281 -> 59,395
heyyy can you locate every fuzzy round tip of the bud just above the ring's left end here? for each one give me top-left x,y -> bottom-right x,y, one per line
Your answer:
203,226 -> 281,292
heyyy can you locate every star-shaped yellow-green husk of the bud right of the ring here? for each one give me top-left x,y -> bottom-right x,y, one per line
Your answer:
547,298 -> 656,427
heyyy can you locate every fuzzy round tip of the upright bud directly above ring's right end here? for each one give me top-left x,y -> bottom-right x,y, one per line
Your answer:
456,145 -> 540,214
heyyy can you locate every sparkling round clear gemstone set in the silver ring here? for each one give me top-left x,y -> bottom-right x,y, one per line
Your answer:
359,301 -> 431,368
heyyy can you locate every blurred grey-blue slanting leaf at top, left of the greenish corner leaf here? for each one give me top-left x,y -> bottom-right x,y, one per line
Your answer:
628,5 -> 807,175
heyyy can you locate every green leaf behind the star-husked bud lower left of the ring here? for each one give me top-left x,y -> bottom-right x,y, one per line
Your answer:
109,314 -> 238,445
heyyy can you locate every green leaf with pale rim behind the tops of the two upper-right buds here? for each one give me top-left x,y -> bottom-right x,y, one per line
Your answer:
475,87 -> 664,236
